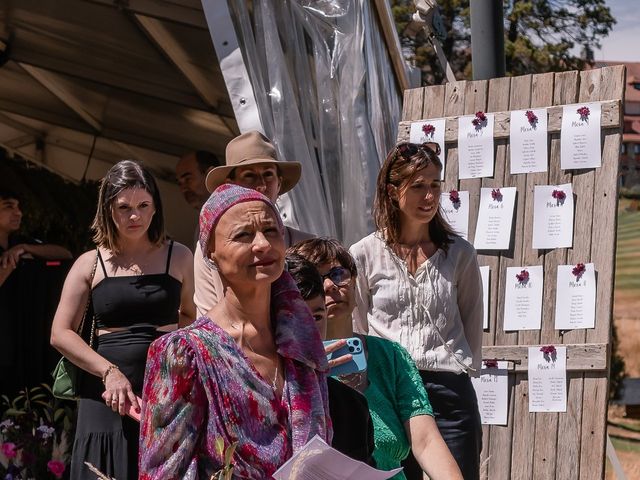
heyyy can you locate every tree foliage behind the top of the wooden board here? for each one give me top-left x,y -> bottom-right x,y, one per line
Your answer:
391,0 -> 615,85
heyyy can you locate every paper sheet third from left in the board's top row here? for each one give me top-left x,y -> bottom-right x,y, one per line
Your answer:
509,108 -> 549,175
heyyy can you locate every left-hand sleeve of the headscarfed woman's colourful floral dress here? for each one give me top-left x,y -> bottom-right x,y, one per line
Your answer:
139,335 -> 207,480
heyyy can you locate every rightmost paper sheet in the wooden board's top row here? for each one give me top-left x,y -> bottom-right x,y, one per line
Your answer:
560,103 -> 602,169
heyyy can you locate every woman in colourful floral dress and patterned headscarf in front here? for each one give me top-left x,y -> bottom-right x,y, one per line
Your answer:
140,184 -> 332,480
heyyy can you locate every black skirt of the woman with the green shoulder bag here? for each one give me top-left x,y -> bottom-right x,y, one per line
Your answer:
71,326 -> 163,480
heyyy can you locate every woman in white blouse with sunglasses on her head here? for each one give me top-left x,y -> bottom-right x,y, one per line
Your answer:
350,143 -> 483,480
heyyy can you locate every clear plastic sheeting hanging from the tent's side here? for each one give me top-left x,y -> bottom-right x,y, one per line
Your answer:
229,0 -> 401,245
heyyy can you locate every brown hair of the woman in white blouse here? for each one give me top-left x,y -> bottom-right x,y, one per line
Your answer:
373,143 -> 456,251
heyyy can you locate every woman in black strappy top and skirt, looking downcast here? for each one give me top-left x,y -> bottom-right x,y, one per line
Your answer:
51,160 -> 195,480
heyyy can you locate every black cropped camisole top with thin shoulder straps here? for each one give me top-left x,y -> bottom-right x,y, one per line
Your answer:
91,241 -> 182,328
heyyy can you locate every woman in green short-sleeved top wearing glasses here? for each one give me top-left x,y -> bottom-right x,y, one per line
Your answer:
288,238 -> 462,480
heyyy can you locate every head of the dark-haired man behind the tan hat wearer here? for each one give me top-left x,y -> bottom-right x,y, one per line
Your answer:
176,150 -> 222,210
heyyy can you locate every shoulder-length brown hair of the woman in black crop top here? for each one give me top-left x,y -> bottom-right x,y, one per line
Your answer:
91,160 -> 166,253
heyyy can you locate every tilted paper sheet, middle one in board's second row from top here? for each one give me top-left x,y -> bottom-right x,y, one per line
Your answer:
473,187 -> 516,250
